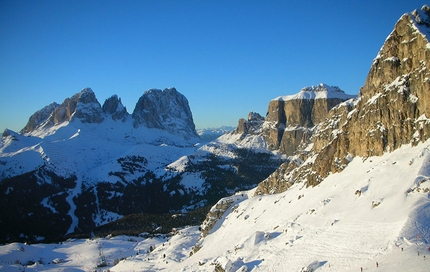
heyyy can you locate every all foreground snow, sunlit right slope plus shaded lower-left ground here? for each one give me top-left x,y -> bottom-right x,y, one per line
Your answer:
0,140 -> 430,272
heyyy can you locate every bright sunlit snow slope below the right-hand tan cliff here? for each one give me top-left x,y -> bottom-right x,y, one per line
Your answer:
174,142 -> 430,271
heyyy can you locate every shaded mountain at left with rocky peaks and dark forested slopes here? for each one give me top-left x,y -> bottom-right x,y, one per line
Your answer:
0,88 -> 282,241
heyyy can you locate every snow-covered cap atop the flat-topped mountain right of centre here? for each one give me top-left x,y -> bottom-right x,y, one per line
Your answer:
272,83 -> 356,101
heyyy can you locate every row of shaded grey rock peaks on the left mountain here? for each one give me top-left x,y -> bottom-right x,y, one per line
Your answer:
21,88 -> 199,140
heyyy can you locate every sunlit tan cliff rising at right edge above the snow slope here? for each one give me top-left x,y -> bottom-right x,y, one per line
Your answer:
257,6 -> 430,194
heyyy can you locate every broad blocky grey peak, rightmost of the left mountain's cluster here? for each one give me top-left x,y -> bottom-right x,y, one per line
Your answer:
132,88 -> 198,139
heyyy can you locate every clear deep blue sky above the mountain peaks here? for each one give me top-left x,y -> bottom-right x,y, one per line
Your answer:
0,0 -> 425,131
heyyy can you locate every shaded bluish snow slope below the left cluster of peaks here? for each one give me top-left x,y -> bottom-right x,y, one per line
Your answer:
0,118 -> 201,228
